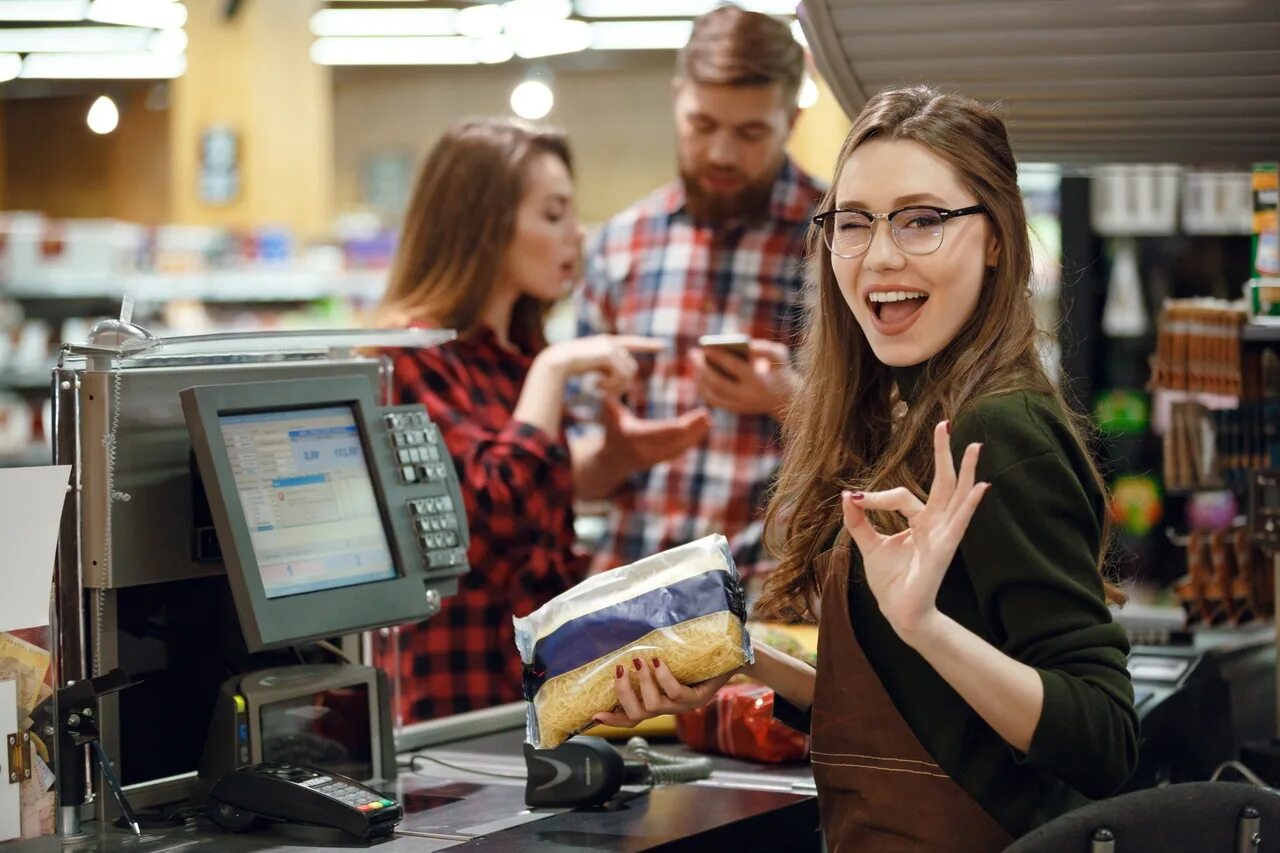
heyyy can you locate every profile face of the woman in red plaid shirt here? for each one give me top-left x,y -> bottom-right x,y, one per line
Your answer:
503,154 -> 582,302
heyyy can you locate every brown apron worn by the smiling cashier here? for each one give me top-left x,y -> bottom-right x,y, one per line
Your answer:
810,546 -> 1012,853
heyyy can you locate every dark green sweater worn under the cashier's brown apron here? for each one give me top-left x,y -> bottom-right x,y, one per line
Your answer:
780,375 -> 1138,838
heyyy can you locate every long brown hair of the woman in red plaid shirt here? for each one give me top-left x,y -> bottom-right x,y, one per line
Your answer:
378,119 -> 572,347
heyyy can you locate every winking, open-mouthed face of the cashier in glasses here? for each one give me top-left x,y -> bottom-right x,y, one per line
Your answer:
831,140 -> 998,368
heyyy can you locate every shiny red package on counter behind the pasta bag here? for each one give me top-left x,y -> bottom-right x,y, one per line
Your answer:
676,681 -> 809,763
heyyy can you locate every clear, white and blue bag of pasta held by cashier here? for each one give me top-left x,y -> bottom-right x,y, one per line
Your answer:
515,534 -> 755,749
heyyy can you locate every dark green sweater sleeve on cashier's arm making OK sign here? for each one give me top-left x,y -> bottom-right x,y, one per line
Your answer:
957,437 -> 1138,798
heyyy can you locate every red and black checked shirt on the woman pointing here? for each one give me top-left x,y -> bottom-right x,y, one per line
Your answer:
379,328 -> 586,722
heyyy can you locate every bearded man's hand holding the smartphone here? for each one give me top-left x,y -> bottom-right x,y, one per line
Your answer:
689,338 -> 796,421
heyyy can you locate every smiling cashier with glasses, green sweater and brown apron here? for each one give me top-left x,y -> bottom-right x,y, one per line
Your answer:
599,87 -> 1138,853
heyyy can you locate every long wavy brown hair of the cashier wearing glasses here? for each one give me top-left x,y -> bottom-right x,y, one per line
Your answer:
756,86 -> 1124,620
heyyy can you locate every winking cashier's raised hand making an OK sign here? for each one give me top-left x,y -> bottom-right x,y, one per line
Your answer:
841,421 -> 991,644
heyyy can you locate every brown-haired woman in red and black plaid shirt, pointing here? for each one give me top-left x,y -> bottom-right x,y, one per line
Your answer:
380,120 -> 709,722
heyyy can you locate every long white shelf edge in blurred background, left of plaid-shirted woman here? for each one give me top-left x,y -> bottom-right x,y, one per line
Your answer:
0,269 -> 387,302
